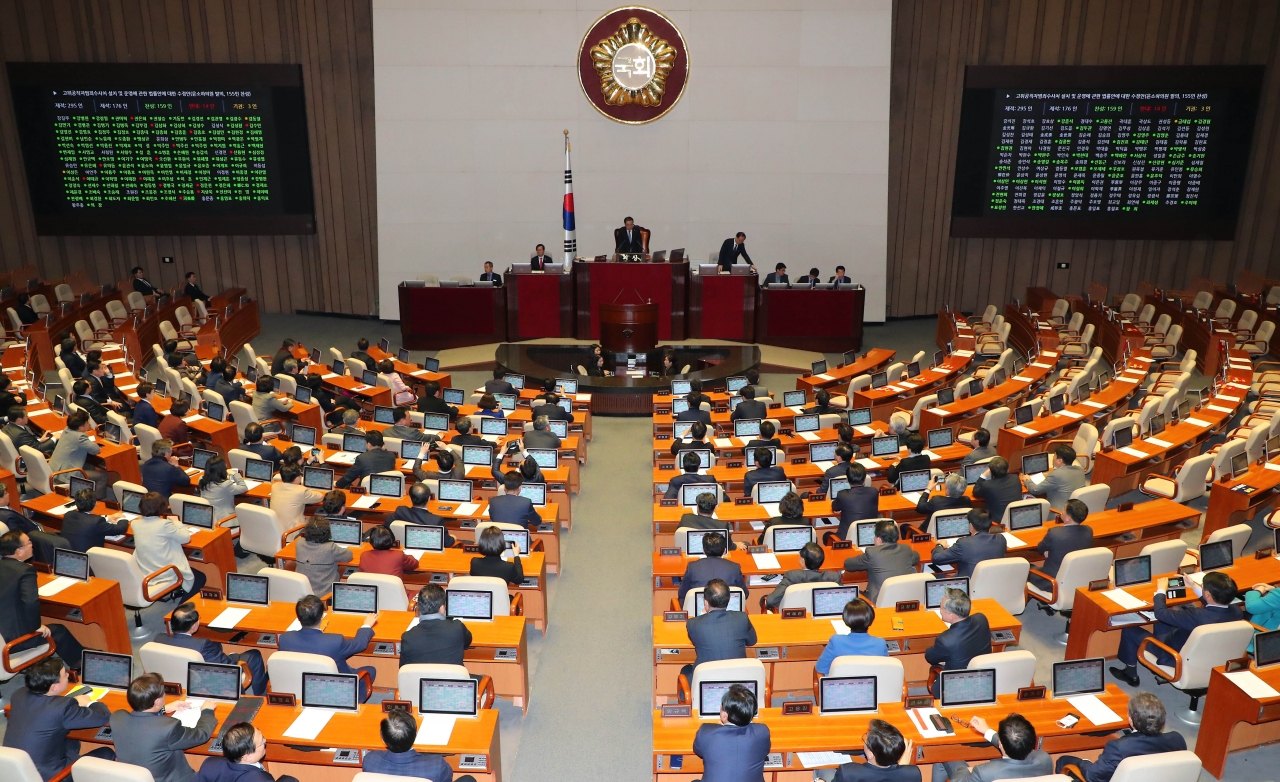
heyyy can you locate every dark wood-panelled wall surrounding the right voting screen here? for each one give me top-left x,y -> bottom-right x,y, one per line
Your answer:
888,0 -> 1280,316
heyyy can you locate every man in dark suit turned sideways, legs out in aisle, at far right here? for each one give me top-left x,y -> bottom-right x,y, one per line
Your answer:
1110,571 -> 1244,687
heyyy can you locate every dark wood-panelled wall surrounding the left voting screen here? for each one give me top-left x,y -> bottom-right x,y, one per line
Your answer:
0,0 -> 378,315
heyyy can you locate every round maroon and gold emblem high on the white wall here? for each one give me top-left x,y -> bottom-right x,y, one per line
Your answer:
577,5 -> 689,125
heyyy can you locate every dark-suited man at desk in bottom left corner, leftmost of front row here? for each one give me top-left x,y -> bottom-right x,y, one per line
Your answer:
4,655 -> 115,781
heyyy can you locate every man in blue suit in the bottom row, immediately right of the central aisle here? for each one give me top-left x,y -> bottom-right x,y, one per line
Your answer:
694,685 -> 772,782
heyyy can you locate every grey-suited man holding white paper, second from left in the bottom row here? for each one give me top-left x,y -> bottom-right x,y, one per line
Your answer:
111,673 -> 218,782
